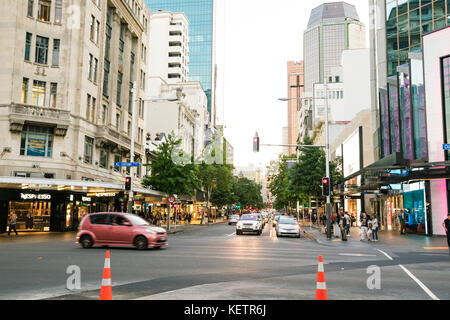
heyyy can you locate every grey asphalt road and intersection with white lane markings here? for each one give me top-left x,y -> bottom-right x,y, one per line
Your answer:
0,220 -> 450,300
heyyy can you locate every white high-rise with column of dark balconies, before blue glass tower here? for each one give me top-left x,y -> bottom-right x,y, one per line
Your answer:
148,11 -> 189,84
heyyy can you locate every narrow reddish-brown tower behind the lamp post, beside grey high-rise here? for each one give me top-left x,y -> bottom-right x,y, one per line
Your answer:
287,61 -> 304,155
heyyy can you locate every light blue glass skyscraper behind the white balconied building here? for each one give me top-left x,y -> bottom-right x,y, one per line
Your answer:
145,0 -> 214,122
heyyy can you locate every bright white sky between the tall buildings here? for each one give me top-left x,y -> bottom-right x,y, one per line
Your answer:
216,0 -> 369,167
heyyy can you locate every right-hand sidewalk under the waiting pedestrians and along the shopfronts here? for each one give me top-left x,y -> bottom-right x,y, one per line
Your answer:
302,224 -> 449,252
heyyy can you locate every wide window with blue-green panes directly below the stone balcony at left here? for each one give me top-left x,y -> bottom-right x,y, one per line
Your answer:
20,125 -> 53,158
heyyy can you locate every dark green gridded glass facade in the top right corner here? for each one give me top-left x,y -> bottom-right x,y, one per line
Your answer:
386,0 -> 450,76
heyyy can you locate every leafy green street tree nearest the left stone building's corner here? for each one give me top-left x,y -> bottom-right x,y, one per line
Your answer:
143,134 -> 199,196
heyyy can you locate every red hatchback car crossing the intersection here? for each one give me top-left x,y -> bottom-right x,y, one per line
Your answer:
76,212 -> 168,250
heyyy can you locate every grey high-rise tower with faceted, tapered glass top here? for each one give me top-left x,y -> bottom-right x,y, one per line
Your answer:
303,2 -> 366,94
